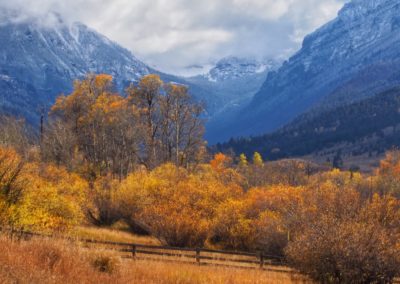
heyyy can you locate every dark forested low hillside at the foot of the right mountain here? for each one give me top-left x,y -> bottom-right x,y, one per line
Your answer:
216,88 -> 400,165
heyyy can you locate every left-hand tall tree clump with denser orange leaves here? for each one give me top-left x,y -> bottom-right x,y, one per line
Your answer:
47,75 -> 139,178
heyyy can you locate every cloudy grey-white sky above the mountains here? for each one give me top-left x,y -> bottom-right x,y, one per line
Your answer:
0,0 -> 346,74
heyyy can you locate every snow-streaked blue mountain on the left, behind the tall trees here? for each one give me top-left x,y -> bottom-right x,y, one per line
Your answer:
0,11 -> 151,119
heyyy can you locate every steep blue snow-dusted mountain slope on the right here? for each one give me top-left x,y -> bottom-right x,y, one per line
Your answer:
216,0 -> 400,141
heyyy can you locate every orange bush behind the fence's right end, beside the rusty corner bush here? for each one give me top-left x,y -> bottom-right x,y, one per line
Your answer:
213,186 -> 303,254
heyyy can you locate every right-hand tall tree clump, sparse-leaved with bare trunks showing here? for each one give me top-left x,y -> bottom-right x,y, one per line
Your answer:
127,75 -> 205,169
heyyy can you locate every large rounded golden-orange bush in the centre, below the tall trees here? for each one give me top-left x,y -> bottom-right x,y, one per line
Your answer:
117,164 -> 240,246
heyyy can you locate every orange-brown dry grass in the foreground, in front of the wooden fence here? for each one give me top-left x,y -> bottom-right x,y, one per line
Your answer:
0,235 -> 306,284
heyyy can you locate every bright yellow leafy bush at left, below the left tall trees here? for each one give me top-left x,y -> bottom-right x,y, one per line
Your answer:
17,165 -> 88,230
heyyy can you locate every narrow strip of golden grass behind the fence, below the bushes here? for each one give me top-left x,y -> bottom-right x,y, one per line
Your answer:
69,227 -> 160,245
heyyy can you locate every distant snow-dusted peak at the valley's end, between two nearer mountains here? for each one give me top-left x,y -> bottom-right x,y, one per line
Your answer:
186,56 -> 280,143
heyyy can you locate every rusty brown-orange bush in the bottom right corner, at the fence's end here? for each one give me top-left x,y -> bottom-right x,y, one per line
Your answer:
286,192 -> 400,283
